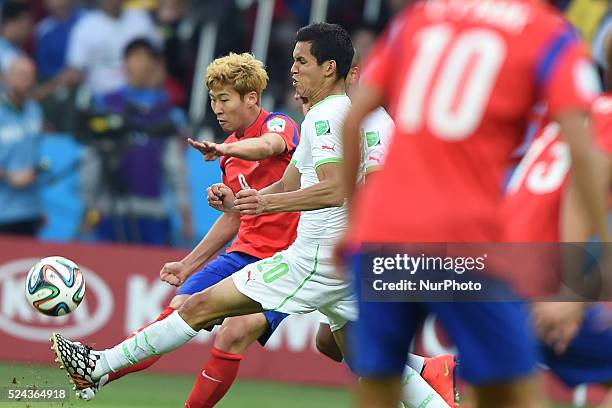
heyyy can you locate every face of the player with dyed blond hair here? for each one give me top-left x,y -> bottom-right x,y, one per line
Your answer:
208,85 -> 250,132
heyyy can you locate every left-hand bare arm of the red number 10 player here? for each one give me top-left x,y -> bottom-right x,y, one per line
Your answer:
341,86 -> 383,203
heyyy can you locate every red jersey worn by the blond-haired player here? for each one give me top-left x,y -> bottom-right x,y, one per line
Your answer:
220,109 -> 300,258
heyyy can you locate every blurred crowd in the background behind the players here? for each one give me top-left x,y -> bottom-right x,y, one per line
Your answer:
0,0 -> 612,246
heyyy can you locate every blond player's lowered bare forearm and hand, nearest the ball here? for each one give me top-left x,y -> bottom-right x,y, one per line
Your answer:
159,212 -> 240,286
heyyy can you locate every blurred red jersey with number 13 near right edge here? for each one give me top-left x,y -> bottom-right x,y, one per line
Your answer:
504,96 -> 612,242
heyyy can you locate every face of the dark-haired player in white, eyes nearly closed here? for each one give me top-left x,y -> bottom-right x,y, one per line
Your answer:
291,41 -> 325,98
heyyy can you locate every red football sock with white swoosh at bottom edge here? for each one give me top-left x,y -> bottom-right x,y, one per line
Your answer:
185,347 -> 242,408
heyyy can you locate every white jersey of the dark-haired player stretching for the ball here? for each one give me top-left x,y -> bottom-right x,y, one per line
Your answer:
291,95 -> 351,242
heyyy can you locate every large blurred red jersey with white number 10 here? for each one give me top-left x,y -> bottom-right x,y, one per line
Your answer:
349,0 -> 598,242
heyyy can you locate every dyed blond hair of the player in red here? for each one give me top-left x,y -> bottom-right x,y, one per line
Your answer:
206,52 -> 268,97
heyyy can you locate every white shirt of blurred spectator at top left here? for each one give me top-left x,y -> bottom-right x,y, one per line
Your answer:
67,0 -> 157,96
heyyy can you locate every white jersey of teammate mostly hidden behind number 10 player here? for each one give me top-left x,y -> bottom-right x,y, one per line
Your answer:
361,107 -> 395,175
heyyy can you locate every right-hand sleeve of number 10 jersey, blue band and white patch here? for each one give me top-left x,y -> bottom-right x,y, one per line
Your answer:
536,23 -> 600,117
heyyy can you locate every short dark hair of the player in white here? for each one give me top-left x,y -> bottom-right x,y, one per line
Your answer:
295,23 -> 354,79
